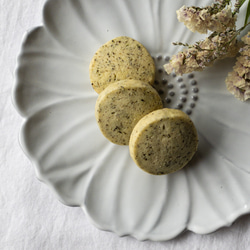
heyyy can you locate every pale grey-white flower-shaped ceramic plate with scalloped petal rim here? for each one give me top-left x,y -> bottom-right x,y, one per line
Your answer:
13,0 -> 250,240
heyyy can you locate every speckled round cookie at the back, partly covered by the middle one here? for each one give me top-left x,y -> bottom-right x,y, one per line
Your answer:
89,36 -> 155,94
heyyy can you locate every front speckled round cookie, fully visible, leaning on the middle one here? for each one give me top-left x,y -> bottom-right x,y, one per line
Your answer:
129,108 -> 198,175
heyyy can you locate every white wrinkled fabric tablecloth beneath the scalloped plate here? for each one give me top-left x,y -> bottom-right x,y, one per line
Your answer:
0,0 -> 250,250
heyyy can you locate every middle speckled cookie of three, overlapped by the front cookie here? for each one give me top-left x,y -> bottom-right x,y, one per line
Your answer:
95,80 -> 163,145
